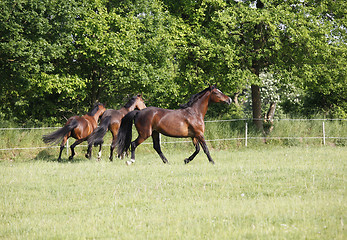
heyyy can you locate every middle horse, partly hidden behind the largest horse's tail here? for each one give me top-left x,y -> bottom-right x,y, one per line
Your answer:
86,94 -> 146,161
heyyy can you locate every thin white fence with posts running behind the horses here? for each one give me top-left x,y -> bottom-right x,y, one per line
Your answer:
0,119 -> 347,154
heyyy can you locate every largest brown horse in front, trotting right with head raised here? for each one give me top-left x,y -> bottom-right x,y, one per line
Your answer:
116,85 -> 231,165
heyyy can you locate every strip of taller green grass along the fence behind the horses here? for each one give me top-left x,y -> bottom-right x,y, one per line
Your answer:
0,120 -> 347,161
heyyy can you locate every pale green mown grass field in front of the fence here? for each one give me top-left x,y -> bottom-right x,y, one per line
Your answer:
0,147 -> 347,239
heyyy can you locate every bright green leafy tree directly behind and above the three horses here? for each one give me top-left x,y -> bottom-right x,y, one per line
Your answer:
74,0 -> 186,107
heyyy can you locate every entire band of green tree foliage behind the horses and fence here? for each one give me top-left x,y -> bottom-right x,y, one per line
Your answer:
0,0 -> 347,125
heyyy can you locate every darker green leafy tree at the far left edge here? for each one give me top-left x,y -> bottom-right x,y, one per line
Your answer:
0,0 -> 83,121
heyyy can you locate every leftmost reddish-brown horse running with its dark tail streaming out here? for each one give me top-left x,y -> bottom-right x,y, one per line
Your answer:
42,103 -> 106,161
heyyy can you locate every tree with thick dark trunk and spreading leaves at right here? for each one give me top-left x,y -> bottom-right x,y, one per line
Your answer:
213,0 -> 346,130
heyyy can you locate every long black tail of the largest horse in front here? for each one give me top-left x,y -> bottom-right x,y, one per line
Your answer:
116,110 -> 139,156
